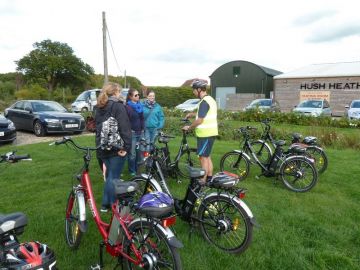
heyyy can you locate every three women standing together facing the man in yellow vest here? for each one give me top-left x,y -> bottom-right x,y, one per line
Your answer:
95,83 -> 165,212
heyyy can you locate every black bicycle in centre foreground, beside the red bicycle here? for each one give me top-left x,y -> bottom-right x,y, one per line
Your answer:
131,134 -> 256,253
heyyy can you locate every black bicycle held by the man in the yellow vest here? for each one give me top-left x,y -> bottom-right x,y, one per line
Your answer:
138,119 -> 201,182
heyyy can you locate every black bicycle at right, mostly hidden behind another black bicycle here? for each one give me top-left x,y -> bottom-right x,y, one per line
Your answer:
251,118 -> 328,173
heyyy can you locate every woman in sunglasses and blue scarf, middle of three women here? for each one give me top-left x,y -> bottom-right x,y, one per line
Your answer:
126,88 -> 144,176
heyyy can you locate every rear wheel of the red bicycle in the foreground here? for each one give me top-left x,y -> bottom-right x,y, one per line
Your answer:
120,220 -> 181,270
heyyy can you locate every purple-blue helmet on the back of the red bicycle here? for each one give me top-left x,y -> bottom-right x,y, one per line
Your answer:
138,191 -> 174,218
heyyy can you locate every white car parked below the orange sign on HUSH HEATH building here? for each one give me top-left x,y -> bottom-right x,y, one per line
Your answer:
293,99 -> 332,117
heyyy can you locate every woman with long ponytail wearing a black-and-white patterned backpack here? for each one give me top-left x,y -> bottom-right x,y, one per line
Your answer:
95,82 -> 131,212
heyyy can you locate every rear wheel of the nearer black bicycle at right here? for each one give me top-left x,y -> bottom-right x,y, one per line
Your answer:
279,156 -> 318,192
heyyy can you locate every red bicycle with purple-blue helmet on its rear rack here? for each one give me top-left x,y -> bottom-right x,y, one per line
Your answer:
52,137 -> 182,270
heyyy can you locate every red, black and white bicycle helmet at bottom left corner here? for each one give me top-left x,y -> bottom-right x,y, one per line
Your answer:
5,242 -> 56,270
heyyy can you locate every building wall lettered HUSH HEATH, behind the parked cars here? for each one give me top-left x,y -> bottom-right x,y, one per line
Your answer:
274,76 -> 360,115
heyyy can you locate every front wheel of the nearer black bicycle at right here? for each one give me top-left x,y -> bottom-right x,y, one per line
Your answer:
220,151 -> 250,181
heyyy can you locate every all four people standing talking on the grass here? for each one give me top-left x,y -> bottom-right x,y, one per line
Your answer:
95,80 -> 218,212
